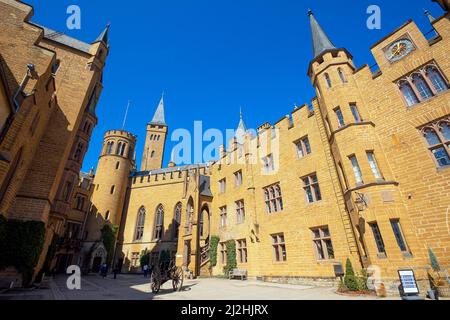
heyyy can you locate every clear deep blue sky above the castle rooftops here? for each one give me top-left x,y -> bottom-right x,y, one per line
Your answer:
26,0 -> 443,170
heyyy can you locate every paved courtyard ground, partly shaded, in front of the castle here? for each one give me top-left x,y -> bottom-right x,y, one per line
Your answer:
0,275 -> 396,300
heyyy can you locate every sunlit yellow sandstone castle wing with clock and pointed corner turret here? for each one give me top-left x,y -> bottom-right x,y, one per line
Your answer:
86,4 -> 450,292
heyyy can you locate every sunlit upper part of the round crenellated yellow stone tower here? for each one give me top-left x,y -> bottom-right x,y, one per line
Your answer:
92,130 -> 136,226
